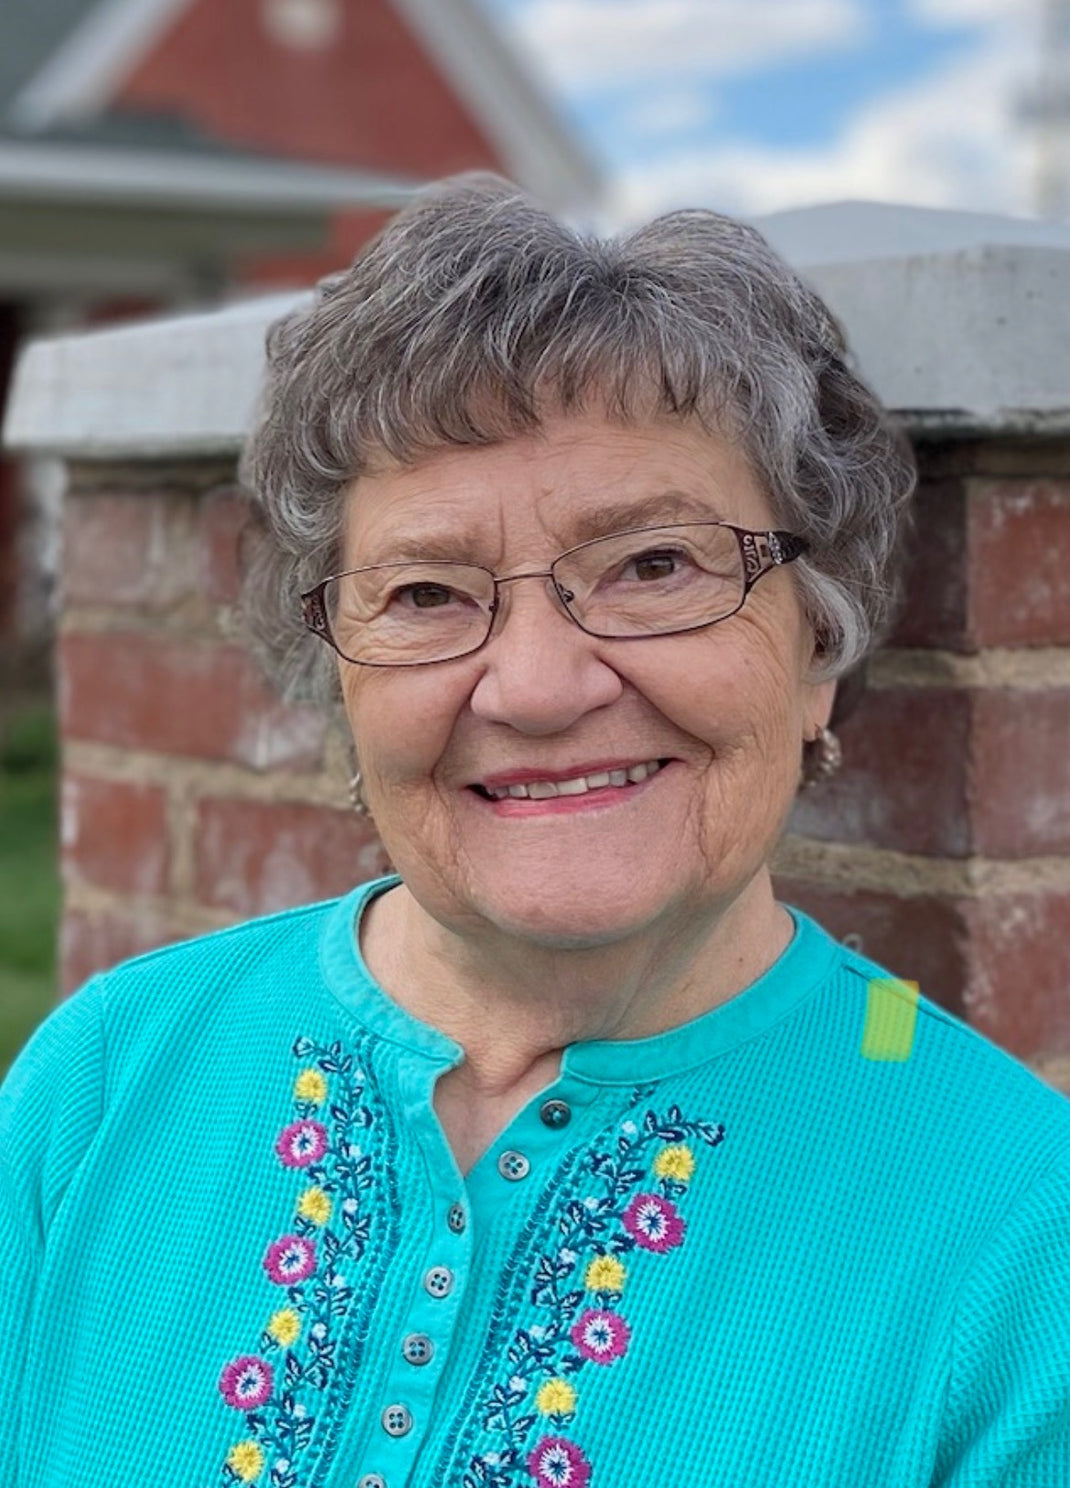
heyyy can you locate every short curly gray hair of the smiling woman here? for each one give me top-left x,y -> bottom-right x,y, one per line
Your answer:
243,176 -> 914,696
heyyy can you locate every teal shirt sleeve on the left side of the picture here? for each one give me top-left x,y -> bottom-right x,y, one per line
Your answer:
0,984 -> 103,1485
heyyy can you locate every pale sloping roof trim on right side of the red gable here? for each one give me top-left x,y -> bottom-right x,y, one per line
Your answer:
391,0 -> 603,213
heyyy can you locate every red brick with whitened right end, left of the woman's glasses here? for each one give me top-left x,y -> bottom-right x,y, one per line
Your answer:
58,631 -> 326,769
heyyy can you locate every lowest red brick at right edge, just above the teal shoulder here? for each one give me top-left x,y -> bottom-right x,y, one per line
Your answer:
963,891 -> 1070,1061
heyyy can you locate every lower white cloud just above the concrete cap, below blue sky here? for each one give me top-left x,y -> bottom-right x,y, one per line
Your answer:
616,11 -> 1034,220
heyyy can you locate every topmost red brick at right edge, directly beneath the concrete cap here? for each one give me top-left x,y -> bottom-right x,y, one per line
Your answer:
967,479 -> 1070,646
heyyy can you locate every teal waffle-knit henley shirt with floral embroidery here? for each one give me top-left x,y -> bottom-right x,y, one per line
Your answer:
0,884 -> 1070,1488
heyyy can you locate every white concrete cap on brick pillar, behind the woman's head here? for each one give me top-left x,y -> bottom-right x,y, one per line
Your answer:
4,202 -> 1070,460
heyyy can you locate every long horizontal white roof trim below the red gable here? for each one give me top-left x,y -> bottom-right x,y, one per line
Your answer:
0,141 -> 415,216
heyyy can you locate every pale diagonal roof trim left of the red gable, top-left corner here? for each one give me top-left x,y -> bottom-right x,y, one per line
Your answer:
9,0 -> 190,129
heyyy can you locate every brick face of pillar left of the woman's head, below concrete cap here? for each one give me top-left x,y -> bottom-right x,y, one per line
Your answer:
57,461 -> 385,991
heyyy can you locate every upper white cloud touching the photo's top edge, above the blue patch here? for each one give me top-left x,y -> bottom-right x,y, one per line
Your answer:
503,0 -> 866,91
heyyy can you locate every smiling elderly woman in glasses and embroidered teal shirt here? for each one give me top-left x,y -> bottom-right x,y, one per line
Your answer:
0,179 -> 1070,1488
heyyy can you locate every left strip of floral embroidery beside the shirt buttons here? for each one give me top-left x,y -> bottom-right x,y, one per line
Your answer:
219,1039 -> 386,1488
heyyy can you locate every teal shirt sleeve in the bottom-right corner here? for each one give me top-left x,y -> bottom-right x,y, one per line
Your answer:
933,1153 -> 1070,1488
